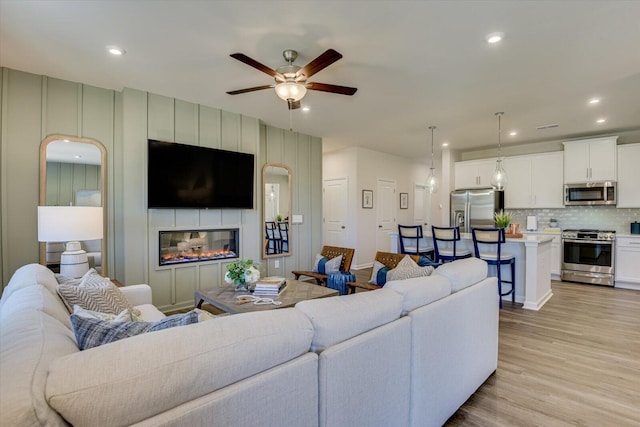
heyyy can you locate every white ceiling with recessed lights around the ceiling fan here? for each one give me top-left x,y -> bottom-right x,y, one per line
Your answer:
0,0 -> 640,160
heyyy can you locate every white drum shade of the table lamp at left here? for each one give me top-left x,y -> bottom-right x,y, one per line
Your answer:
38,206 -> 103,242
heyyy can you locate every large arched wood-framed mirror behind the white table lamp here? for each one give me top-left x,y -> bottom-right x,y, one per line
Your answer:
39,135 -> 107,276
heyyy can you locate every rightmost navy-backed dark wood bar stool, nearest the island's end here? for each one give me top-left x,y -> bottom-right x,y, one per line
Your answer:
471,228 -> 516,308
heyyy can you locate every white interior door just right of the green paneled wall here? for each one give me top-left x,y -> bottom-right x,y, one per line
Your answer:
322,178 -> 349,247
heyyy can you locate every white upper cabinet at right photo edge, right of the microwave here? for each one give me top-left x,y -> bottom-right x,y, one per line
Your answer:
617,144 -> 640,208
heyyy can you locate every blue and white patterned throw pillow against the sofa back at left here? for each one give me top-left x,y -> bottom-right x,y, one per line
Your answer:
71,310 -> 198,350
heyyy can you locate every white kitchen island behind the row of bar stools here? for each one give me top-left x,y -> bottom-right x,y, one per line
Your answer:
389,230 -> 554,310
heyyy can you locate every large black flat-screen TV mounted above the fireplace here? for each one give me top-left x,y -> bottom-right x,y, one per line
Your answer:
147,139 -> 254,209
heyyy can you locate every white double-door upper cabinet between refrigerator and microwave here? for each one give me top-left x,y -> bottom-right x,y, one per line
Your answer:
504,151 -> 564,209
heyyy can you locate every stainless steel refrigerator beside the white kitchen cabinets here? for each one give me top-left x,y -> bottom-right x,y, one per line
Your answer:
450,188 -> 504,233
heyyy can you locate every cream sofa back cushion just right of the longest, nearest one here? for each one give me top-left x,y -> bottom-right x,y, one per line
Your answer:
296,288 -> 402,352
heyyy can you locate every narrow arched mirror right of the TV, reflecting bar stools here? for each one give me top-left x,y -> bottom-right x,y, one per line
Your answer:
262,163 -> 292,258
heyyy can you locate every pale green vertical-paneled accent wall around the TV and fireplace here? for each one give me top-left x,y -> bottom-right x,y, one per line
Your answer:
0,68 -> 322,310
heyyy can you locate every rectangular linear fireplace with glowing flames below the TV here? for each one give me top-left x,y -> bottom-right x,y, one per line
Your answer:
158,228 -> 240,266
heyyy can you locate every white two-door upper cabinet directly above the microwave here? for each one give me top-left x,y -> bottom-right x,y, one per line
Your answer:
564,136 -> 618,184
